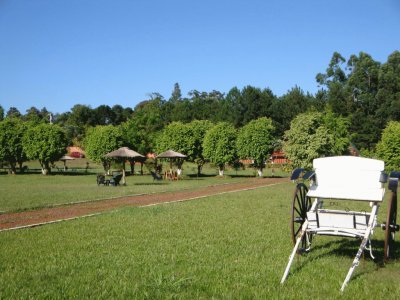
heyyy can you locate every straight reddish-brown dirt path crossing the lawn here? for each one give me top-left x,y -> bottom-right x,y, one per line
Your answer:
0,178 -> 288,231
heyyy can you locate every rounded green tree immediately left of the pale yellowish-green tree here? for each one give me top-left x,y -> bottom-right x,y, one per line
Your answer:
236,117 -> 275,177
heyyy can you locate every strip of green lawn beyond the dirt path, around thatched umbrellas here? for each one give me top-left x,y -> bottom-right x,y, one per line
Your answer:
0,160 -> 283,213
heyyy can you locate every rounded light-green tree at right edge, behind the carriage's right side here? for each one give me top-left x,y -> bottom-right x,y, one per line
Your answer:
376,121 -> 400,171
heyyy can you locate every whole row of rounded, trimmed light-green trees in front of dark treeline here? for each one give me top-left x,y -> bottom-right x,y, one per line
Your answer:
0,111 -> 400,176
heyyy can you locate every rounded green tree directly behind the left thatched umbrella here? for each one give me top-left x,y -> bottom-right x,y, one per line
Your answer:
84,125 -> 123,172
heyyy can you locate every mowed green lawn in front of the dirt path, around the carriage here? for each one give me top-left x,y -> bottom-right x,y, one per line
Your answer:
0,183 -> 400,299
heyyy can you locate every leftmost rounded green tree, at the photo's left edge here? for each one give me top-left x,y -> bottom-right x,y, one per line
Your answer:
0,118 -> 27,174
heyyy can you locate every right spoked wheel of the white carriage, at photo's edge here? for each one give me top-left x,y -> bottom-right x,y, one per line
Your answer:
384,192 -> 399,261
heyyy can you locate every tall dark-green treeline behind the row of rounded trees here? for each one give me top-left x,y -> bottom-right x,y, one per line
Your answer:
0,51 -> 400,151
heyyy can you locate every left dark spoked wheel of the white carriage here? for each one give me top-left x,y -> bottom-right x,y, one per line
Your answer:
291,183 -> 311,253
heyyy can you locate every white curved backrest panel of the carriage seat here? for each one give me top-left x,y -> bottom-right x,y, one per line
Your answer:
307,156 -> 385,202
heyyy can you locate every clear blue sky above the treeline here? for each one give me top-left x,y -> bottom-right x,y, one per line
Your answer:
0,0 -> 400,113
